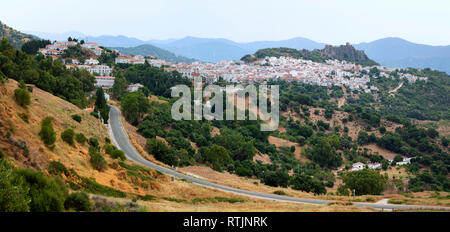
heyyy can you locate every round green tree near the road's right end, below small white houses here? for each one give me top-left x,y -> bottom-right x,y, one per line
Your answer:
342,169 -> 386,195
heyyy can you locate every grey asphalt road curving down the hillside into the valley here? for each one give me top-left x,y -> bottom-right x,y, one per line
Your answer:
109,106 -> 450,210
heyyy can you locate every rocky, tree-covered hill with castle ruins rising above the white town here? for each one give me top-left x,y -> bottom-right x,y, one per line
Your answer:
241,43 -> 377,65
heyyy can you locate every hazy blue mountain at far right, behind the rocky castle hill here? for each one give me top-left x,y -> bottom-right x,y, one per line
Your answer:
354,38 -> 450,73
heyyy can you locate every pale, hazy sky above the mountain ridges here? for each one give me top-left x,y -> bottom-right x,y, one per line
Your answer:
0,0 -> 450,45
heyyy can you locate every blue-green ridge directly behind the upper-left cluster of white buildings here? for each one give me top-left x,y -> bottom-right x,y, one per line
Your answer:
109,44 -> 195,63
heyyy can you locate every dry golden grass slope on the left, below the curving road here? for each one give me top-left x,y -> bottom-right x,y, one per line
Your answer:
0,79 -> 371,211
